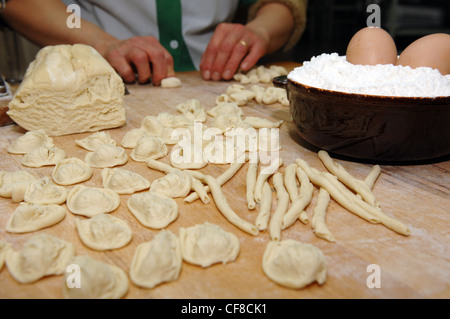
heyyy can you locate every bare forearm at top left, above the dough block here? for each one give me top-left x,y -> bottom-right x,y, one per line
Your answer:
1,0 -> 117,53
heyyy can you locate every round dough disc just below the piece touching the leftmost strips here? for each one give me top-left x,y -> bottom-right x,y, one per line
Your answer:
127,192 -> 178,229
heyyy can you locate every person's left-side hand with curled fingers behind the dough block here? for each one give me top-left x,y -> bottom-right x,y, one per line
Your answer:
100,36 -> 175,85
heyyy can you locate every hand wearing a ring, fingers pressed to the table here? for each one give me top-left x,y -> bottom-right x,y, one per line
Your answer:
200,23 -> 269,81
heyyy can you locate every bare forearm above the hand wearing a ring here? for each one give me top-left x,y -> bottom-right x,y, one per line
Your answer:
246,2 -> 294,53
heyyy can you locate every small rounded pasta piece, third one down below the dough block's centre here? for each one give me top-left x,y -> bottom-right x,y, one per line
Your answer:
52,157 -> 93,185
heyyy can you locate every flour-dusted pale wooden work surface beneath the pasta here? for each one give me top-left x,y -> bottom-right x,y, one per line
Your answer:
0,64 -> 450,299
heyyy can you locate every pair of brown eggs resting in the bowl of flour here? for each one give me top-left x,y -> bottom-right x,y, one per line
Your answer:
346,27 -> 450,75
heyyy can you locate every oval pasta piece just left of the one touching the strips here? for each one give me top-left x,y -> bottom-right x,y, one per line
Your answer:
101,168 -> 151,194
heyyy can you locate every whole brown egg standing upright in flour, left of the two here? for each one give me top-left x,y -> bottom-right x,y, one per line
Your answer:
346,27 -> 397,65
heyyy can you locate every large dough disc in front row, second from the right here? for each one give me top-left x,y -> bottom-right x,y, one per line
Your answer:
179,222 -> 240,268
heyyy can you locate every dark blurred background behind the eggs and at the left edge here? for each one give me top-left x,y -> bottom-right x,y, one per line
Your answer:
0,0 -> 450,81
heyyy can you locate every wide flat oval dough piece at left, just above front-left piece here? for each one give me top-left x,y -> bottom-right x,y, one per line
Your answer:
5,202 -> 67,233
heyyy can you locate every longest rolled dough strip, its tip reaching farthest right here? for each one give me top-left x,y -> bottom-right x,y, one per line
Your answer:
296,159 -> 410,236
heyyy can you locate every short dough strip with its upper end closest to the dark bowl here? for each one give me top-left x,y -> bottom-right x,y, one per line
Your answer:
317,150 -> 376,206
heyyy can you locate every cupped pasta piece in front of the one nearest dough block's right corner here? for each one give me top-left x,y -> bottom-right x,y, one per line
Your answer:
84,144 -> 128,168
